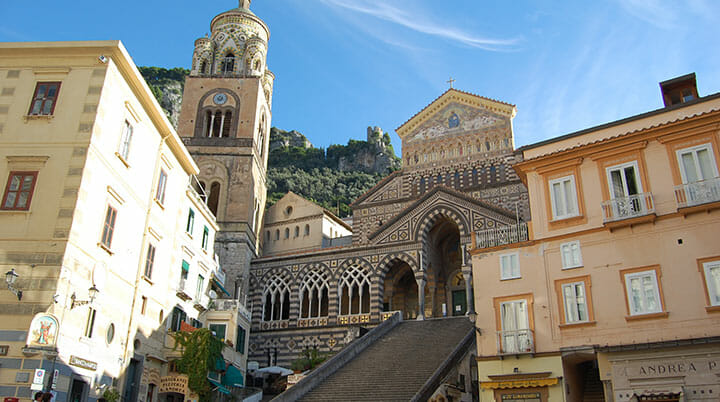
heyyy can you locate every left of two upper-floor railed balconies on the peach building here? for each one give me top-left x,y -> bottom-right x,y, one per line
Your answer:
602,193 -> 655,229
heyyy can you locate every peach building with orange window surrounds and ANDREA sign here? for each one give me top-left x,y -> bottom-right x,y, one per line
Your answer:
471,74 -> 720,402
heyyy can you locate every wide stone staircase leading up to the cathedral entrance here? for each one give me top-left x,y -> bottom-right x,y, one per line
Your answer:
290,317 -> 473,402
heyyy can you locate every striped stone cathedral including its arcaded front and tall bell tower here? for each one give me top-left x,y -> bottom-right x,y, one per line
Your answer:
178,0 -> 529,366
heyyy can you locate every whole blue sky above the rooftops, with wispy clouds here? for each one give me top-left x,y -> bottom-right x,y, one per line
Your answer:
0,0 -> 720,154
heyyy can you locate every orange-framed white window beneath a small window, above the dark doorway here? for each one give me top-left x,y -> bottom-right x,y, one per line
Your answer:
555,275 -> 594,324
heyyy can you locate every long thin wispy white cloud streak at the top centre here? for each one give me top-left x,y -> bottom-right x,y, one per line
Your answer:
321,0 -> 518,51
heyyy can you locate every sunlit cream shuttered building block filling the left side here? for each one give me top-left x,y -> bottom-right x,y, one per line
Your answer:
0,41 -> 249,402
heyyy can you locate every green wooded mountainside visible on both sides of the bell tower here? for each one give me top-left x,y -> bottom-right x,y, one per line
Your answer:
138,67 -> 400,217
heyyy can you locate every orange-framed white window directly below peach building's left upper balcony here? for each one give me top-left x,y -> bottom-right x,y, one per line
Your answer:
620,267 -> 663,316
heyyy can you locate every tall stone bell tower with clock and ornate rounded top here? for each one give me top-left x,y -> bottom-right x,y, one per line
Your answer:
178,0 -> 275,298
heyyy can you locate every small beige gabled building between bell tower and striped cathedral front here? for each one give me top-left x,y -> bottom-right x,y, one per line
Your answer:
262,191 -> 352,256
